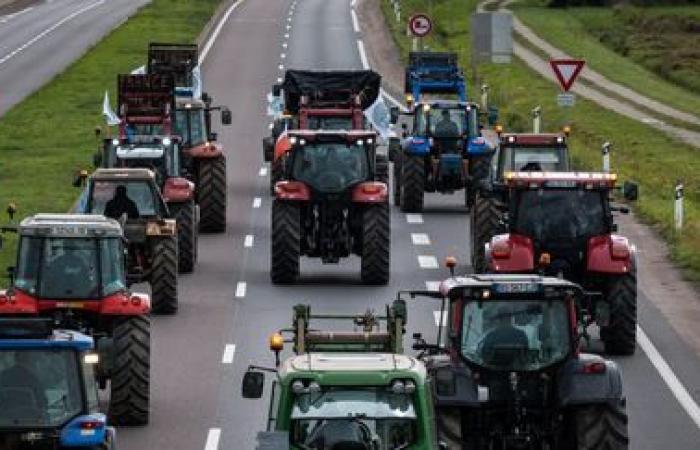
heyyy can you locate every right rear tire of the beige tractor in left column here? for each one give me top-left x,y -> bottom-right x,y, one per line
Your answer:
151,236 -> 178,314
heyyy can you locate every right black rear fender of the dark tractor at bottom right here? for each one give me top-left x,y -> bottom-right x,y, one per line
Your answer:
557,353 -> 622,407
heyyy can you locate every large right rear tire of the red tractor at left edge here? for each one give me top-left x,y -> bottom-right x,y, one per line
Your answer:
109,316 -> 151,425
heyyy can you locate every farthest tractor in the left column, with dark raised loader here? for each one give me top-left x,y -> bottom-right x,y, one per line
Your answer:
148,43 -> 231,233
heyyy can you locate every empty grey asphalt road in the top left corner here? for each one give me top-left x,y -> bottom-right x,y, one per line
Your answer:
0,0 -> 149,115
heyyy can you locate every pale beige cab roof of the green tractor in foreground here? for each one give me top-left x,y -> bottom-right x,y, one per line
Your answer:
280,353 -> 426,384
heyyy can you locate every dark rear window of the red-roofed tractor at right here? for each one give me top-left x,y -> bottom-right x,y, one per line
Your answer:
514,189 -> 608,243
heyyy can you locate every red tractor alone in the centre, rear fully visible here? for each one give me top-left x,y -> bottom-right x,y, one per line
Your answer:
270,130 -> 391,284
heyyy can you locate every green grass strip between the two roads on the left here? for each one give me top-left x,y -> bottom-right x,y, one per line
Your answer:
0,0 -> 220,274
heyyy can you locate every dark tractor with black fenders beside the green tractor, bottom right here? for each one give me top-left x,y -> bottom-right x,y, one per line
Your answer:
409,274 -> 627,450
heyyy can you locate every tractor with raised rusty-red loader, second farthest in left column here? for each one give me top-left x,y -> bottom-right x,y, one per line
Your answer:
95,75 -> 199,273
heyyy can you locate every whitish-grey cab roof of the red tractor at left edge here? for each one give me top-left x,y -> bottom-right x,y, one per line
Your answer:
19,214 -> 122,238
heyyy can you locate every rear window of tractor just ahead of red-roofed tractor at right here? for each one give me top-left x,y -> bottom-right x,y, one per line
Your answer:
498,146 -> 569,174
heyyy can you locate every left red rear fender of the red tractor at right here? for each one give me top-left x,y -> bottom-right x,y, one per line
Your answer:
485,234 -> 535,273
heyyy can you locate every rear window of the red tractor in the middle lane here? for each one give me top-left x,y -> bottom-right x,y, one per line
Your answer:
292,142 -> 370,193
